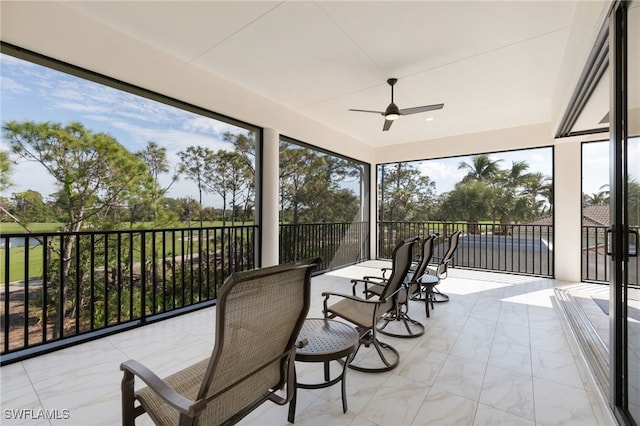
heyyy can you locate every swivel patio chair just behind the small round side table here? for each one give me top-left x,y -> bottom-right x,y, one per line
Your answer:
322,239 -> 416,372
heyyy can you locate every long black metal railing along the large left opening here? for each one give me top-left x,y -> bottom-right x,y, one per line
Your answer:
0,225 -> 257,364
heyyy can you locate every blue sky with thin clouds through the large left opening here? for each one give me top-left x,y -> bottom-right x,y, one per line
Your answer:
0,55 -> 246,205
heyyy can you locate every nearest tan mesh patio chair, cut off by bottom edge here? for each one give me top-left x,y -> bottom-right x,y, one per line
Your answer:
120,258 -> 320,426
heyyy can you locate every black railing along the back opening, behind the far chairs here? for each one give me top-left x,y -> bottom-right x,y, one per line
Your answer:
378,222 -> 554,277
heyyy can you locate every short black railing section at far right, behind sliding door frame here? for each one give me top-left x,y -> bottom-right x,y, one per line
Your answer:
582,226 -> 640,286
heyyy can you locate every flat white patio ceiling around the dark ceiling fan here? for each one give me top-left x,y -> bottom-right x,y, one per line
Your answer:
52,0 -> 576,146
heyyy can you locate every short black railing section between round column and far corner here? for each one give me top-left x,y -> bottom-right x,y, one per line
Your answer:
280,222 -> 369,270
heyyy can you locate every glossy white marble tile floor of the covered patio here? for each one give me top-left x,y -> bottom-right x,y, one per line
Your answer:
0,261 -> 615,426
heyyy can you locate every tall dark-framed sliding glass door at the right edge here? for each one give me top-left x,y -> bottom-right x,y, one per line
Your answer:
610,2 -> 640,425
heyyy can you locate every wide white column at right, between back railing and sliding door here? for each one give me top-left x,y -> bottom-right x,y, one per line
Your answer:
553,141 -> 582,282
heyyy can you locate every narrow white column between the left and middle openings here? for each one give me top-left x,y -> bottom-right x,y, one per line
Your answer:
261,129 -> 280,267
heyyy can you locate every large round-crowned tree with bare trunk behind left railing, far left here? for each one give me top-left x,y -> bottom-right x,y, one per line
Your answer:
3,121 -> 152,330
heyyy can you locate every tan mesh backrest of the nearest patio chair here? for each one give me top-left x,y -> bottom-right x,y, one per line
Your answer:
192,258 -> 321,424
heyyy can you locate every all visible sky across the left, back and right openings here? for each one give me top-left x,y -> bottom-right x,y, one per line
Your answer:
0,55 -> 624,205
